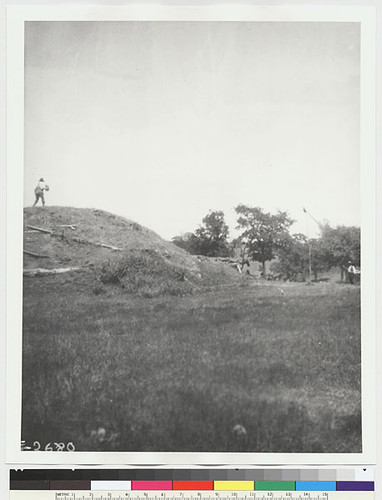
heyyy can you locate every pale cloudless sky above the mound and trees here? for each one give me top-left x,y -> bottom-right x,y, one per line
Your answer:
24,21 -> 360,239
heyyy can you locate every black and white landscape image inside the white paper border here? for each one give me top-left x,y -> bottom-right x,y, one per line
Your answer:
5,5 -> 374,464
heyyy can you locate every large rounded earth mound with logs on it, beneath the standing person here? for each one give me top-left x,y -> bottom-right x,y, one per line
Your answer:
24,207 -> 242,297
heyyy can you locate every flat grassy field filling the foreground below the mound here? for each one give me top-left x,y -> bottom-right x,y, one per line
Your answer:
22,273 -> 361,452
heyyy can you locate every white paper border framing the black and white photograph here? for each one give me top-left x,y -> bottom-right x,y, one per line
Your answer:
6,5 -> 376,465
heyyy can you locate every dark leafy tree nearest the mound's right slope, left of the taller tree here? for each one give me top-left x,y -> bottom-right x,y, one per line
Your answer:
172,210 -> 231,257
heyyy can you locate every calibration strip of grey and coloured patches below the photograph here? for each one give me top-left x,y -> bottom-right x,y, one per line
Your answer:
10,468 -> 374,492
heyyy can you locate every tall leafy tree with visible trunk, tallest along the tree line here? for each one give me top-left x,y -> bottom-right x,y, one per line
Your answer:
235,205 -> 294,277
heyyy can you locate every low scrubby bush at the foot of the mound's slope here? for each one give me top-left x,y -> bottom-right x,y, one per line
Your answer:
99,250 -> 193,298
